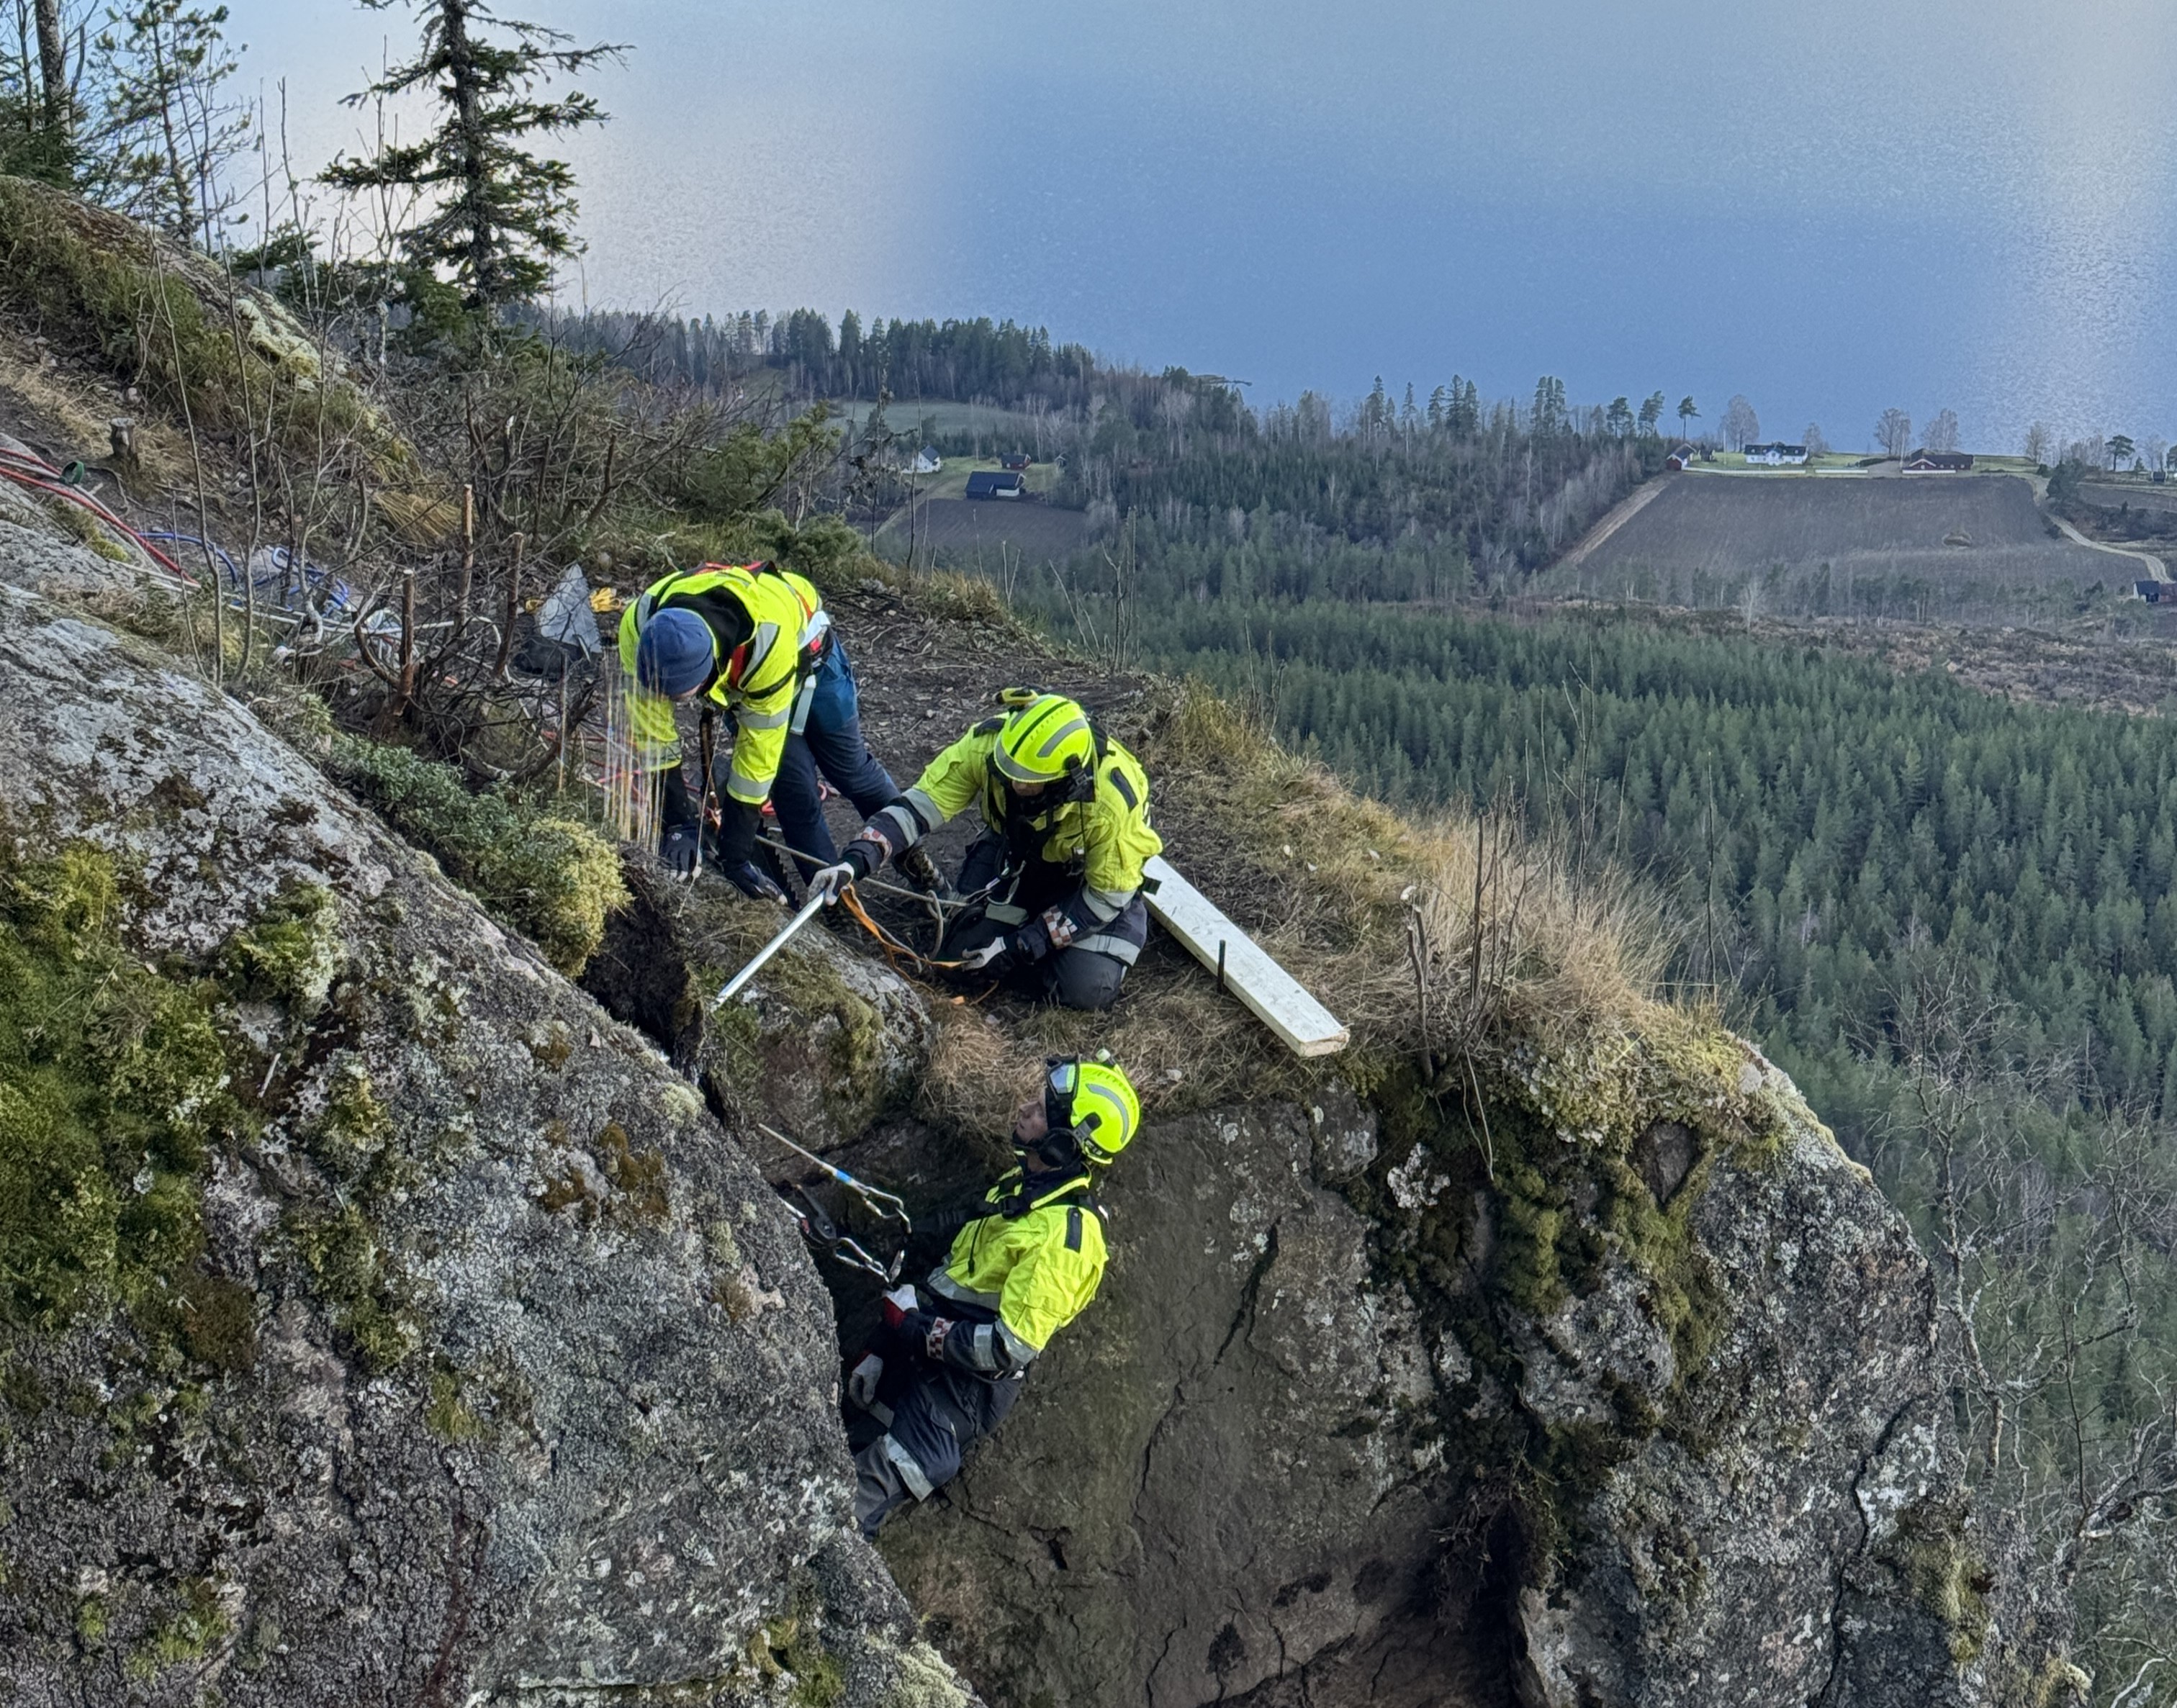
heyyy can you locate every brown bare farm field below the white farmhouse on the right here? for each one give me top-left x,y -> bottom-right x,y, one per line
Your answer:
1537,474 -> 2140,620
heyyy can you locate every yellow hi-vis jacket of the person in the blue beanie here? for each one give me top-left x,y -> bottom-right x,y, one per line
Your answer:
621,564 -> 831,808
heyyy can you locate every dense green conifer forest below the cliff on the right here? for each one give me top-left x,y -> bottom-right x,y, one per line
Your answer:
1017,561 -> 2177,1678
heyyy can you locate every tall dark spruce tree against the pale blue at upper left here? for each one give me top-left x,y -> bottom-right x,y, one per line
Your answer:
325,0 -> 627,315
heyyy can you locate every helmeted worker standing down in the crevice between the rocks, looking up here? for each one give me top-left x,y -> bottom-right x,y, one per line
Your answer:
847,1057 -> 1141,1536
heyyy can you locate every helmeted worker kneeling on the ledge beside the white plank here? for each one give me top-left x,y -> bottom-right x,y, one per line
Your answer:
810,687 -> 1165,1008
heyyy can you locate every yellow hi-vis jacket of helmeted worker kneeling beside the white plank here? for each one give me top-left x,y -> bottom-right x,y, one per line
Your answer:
871,718 -> 1165,929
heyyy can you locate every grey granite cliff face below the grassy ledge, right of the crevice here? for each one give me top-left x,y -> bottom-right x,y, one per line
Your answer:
882,1034 -> 1996,1708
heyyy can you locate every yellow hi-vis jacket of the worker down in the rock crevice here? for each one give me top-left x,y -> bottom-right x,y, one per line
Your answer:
925,1168 -> 1106,1375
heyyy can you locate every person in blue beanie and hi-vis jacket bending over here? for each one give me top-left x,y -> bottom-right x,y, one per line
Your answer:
621,564 -> 936,900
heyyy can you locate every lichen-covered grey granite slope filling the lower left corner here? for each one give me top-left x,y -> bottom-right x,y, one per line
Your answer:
0,574 -> 969,1708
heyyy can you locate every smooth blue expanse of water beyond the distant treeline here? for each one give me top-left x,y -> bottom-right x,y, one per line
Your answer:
216,0 -> 2177,451
